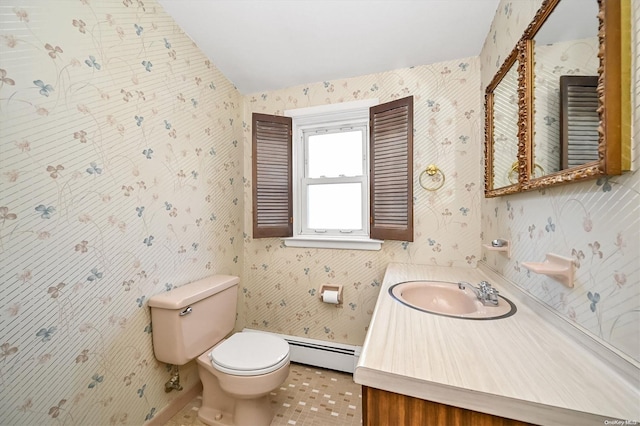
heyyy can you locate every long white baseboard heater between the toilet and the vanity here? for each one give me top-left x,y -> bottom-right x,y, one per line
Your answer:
242,328 -> 362,373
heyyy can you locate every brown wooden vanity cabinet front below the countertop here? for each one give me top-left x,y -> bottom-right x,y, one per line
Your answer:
362,386 -> 530,426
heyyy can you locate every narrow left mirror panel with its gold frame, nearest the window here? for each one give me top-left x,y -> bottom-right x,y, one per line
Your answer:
485,48 -> 521,196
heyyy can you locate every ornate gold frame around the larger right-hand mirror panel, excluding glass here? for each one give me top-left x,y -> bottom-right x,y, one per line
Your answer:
520,0 -> 622,191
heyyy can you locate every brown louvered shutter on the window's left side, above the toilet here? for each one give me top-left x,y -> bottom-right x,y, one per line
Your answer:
252,113 -> 293,238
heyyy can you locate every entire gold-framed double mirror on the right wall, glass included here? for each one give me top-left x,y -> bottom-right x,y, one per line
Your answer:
485,0 -> 631,197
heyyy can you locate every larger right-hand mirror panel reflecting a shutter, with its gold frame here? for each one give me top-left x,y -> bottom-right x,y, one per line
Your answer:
523,0 -> 630,190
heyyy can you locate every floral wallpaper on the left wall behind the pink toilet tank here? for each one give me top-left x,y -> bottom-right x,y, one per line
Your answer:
0,0 -> 243,425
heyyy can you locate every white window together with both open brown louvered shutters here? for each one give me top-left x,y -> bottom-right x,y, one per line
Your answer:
253,97 -> 413,249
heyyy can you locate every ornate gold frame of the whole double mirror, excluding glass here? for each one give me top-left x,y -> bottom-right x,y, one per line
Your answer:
485,0 -> 631,197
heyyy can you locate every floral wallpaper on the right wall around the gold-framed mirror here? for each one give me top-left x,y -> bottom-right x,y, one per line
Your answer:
480,0 -> 640,363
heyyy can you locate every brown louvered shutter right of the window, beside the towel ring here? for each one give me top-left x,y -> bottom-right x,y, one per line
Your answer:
369,96 -> 413,241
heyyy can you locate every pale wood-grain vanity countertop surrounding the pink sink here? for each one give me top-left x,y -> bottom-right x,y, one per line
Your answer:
354,263 -> 640,426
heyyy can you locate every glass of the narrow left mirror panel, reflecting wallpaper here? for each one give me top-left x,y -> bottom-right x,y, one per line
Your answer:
493,63 -> 518,189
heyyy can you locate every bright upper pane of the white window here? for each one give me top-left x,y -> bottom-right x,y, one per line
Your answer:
307,130 -> 363,178
